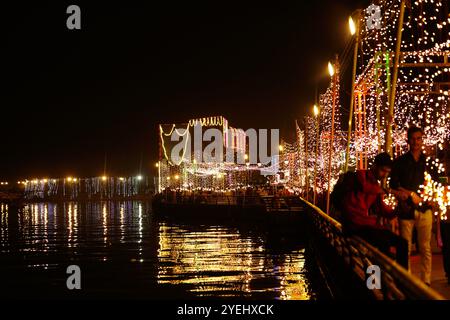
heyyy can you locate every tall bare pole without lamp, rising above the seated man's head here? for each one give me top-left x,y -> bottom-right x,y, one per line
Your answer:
385,0 -> 406,156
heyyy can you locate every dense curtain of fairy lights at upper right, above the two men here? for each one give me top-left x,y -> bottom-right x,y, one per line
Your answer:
351,0 -> 450,157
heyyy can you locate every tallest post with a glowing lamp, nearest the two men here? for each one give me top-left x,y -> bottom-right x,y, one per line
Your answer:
344,10 -> 361,172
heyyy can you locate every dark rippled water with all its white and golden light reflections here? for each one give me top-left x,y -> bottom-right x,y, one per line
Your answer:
0,201 -> 314,299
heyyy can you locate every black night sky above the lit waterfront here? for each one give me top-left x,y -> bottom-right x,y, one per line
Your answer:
0,0 -> 369,180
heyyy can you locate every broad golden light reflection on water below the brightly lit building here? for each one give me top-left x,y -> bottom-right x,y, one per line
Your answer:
158,223 -> 311,300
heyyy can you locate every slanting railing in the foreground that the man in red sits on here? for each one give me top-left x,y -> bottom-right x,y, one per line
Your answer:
301,199 -> 444,300
